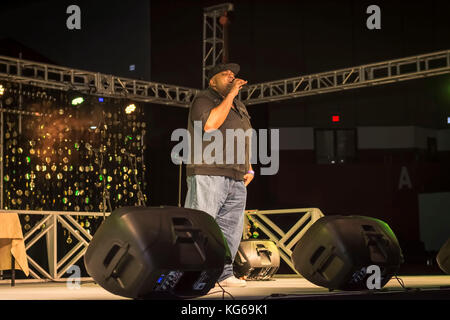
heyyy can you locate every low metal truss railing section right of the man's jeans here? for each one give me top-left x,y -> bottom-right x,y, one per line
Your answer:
244,208 -> 324,274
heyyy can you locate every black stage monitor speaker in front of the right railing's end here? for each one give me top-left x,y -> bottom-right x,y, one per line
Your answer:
292,215 -> 403,290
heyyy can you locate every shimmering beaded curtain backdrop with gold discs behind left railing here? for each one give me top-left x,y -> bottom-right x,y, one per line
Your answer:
0,83 -> 147,243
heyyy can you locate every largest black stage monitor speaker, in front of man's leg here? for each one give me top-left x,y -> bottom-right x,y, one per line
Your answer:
84,207 -> 231,299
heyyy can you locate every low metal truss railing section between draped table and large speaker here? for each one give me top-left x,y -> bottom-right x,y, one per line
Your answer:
0,210 -> 110,281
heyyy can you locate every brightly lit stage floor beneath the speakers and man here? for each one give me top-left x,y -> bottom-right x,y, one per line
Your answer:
0,275 -> 450,300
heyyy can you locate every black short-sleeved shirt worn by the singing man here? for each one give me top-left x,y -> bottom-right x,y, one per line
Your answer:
186,88 -> 252,180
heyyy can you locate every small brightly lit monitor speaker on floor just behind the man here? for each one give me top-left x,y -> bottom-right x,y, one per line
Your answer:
233,239 -> 280,280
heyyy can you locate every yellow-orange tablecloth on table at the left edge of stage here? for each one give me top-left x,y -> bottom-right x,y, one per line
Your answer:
0,213 -> 30,276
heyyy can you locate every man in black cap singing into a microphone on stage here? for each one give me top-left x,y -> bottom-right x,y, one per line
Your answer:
185,63 -> 255,287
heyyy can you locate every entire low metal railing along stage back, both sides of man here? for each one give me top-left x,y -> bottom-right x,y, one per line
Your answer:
0,208 -> 324,283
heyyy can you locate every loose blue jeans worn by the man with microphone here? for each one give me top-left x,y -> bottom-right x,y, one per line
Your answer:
184,175 -> 247,282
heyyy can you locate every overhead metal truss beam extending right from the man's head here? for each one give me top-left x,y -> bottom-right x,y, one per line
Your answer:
239,50 -> 450,105
